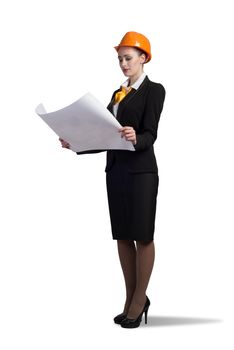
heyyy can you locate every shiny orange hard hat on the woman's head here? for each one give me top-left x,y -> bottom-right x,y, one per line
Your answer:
114,32 -> 152,63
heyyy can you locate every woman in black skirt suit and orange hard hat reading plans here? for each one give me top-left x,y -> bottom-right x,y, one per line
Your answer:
60,32 -> 165,328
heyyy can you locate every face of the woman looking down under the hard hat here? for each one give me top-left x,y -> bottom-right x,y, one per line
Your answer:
118,46 -> 145,77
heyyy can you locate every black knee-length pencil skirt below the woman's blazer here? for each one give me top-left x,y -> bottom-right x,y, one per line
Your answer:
106,162 -> 159,241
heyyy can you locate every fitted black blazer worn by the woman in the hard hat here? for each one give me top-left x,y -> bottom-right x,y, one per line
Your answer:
76,76 -> 166,173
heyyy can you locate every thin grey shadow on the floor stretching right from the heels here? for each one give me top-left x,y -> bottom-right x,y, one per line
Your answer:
142,316 -> 222,327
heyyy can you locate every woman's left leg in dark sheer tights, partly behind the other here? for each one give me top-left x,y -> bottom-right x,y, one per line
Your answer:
117,240 -> 136,313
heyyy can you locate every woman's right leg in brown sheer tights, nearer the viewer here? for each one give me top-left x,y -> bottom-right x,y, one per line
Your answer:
127,241 -> 155,318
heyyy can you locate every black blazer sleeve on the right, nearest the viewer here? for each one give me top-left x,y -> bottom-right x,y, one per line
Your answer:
134,83 -> 166,151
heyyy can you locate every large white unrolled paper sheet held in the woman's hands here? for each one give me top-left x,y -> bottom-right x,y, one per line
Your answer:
35,92 -> 135,152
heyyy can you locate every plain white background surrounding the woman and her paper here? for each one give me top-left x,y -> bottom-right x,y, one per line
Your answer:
0,0 -> 234,350
